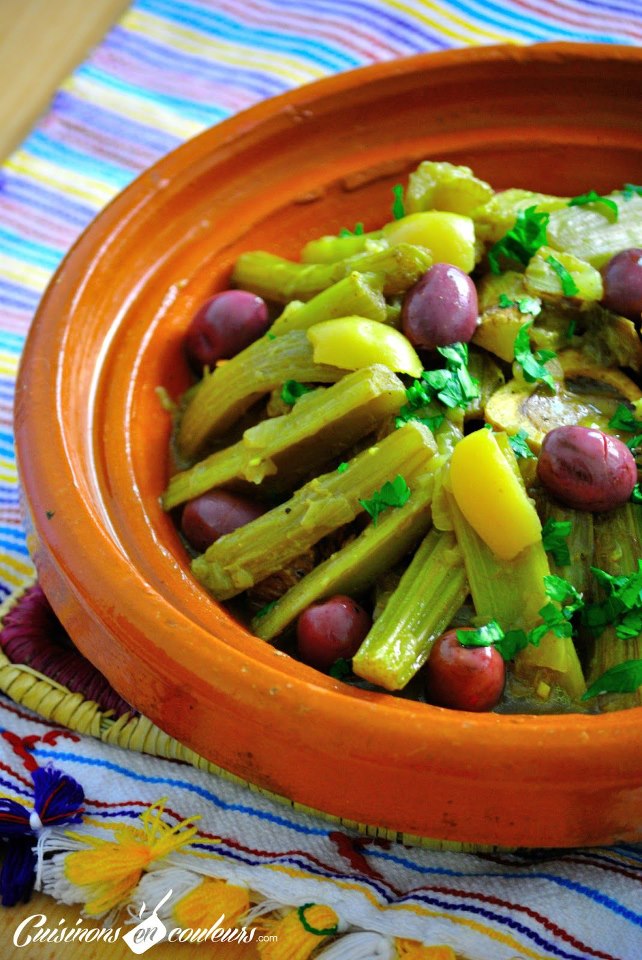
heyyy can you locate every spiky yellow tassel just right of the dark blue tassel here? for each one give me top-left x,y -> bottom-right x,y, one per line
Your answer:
64,800 -> 198,917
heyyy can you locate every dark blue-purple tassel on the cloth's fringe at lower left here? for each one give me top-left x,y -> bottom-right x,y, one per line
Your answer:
0,766 -> 85,907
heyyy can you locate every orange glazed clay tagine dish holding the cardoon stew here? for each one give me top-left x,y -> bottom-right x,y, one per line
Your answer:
16,44 -> 642,848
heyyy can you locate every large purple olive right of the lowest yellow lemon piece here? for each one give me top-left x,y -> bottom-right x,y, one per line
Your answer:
537,427 -> 637,513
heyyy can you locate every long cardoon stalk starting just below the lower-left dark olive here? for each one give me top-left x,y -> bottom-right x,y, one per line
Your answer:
192,422 -> 436,600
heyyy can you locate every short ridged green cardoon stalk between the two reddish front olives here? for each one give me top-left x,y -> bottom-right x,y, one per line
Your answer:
352,530 -> 468,690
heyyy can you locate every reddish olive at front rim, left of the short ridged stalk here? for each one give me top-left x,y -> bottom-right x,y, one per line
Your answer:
296,594 -> 372,670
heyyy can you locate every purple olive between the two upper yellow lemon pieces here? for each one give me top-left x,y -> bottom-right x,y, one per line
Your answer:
401,263 -> 479,350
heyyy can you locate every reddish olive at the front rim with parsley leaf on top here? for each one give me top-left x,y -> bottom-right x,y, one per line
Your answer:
424,627 -> 506,713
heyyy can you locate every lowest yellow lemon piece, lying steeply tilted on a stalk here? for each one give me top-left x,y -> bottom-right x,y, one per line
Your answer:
450,430 -> 542,560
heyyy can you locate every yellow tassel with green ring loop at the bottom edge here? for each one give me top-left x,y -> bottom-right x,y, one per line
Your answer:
257,903 -> 339,960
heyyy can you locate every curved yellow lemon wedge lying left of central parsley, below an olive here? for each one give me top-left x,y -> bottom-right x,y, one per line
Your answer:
307,317 -> 423,377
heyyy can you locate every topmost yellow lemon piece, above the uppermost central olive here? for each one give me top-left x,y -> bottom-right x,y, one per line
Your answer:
382,210 -> 475,273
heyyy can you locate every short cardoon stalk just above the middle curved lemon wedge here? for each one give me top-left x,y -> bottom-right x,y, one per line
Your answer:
270,271 -> 386,336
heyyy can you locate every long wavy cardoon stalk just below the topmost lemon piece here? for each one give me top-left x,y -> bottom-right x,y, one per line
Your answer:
232,243 -> 432,303
